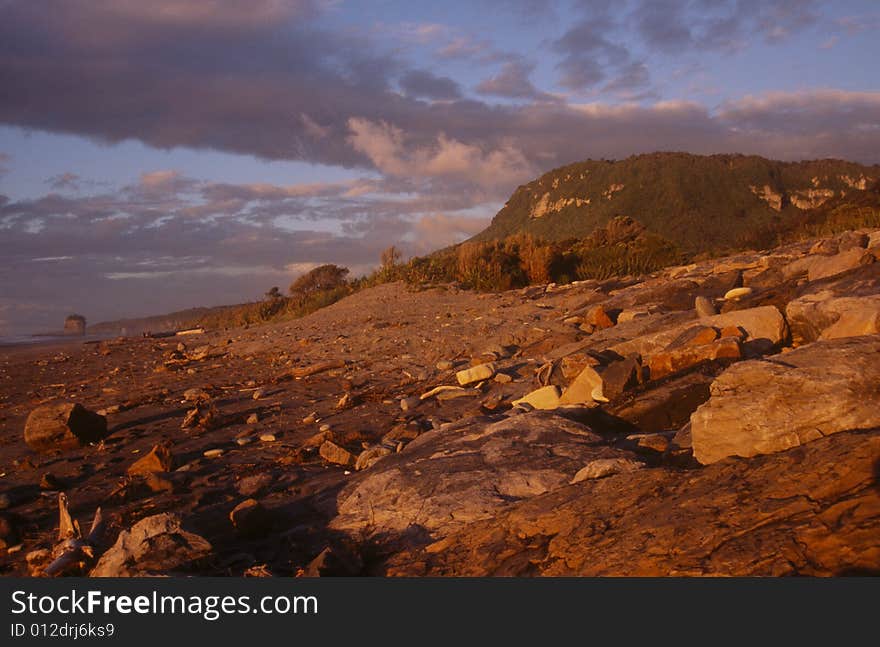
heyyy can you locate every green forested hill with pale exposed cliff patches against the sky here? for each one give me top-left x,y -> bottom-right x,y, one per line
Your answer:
475,153 -> 880,252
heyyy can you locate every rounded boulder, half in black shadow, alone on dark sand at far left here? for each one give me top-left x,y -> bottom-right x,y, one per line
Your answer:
24,402 -> 107,452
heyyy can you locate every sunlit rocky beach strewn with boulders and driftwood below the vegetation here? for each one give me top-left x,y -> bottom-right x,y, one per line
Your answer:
0,232 -> 880,576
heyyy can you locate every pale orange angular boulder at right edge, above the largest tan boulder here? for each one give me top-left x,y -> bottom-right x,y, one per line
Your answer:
785,289 -> 880,345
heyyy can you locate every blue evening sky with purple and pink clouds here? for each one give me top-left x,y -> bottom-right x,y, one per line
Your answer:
0,0 -> 880,336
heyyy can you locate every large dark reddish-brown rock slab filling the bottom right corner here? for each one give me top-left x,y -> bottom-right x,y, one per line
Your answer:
383,430 -> 880,577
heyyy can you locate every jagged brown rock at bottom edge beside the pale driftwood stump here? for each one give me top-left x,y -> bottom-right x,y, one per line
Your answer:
89,513 -> 212,577
